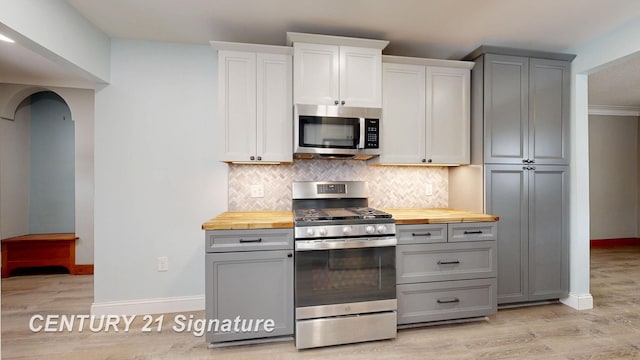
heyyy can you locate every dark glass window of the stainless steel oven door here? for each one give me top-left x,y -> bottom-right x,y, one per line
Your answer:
295,247 -> 396,307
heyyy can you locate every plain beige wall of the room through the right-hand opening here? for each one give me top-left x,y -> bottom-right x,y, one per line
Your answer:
589,115 -> 638,239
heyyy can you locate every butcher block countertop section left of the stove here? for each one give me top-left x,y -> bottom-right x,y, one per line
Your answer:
202,211 -> 293,230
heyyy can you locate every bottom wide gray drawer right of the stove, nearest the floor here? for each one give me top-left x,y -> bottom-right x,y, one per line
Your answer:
397,278 -> 497,325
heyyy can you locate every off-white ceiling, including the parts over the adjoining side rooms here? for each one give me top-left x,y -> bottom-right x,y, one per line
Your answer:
0,0 -> 640,108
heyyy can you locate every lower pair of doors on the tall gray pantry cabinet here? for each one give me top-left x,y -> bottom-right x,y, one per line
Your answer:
485,165 -> 569,304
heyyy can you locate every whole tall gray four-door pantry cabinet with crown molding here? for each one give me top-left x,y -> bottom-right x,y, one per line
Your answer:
468,47 -> 575,305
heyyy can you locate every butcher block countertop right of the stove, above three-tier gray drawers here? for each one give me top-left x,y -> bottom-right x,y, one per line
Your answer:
381,208 -> 499,225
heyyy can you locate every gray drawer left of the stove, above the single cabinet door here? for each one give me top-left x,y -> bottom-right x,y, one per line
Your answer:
205,229 -> 293,252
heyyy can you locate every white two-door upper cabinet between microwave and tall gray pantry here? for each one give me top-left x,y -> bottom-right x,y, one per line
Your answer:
372,56 -> 473,166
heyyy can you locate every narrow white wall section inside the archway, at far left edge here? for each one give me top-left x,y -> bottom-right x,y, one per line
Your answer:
0,101 -> 31,239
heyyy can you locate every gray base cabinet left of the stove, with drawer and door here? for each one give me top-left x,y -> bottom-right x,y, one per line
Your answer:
205,229 -> 294,344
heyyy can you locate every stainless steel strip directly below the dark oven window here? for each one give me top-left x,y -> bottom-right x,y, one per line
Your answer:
296,299 -> 398,320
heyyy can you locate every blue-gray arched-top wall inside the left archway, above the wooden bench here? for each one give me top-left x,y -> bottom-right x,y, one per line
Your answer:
29,92 -> 75,234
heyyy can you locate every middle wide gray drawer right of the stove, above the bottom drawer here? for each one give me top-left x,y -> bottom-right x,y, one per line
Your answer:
396,241 -> 497,284
